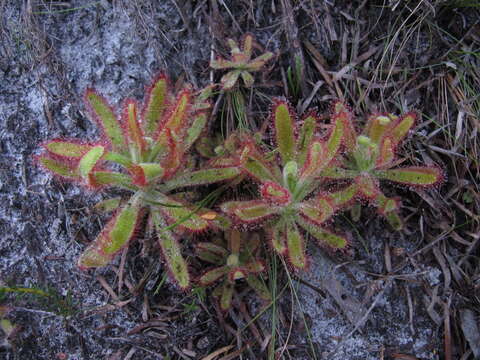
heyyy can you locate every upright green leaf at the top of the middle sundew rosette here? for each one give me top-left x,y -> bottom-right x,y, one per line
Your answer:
273,101 -> 296,165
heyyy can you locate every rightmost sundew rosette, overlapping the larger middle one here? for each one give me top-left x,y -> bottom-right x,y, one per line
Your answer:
322,101 -> 443,230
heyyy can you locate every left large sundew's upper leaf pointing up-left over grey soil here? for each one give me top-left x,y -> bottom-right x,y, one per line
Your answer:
85,89 -> 125,151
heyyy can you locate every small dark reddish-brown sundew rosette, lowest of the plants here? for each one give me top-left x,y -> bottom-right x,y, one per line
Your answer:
196,229 -> 271,311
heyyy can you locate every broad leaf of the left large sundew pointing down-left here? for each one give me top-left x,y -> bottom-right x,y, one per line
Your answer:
78,205 -> 140,268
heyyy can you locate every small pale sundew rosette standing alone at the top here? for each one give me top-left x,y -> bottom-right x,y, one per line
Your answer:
210,34 -> 274,91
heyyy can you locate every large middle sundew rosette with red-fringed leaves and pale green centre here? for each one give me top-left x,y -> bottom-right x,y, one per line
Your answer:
221,100 -> 357,269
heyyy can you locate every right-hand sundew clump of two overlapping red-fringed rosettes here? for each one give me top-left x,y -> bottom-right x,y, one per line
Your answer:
221,100 -> 442,269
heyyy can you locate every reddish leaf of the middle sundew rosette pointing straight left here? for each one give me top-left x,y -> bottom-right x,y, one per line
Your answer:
220,200 -> 278,223
